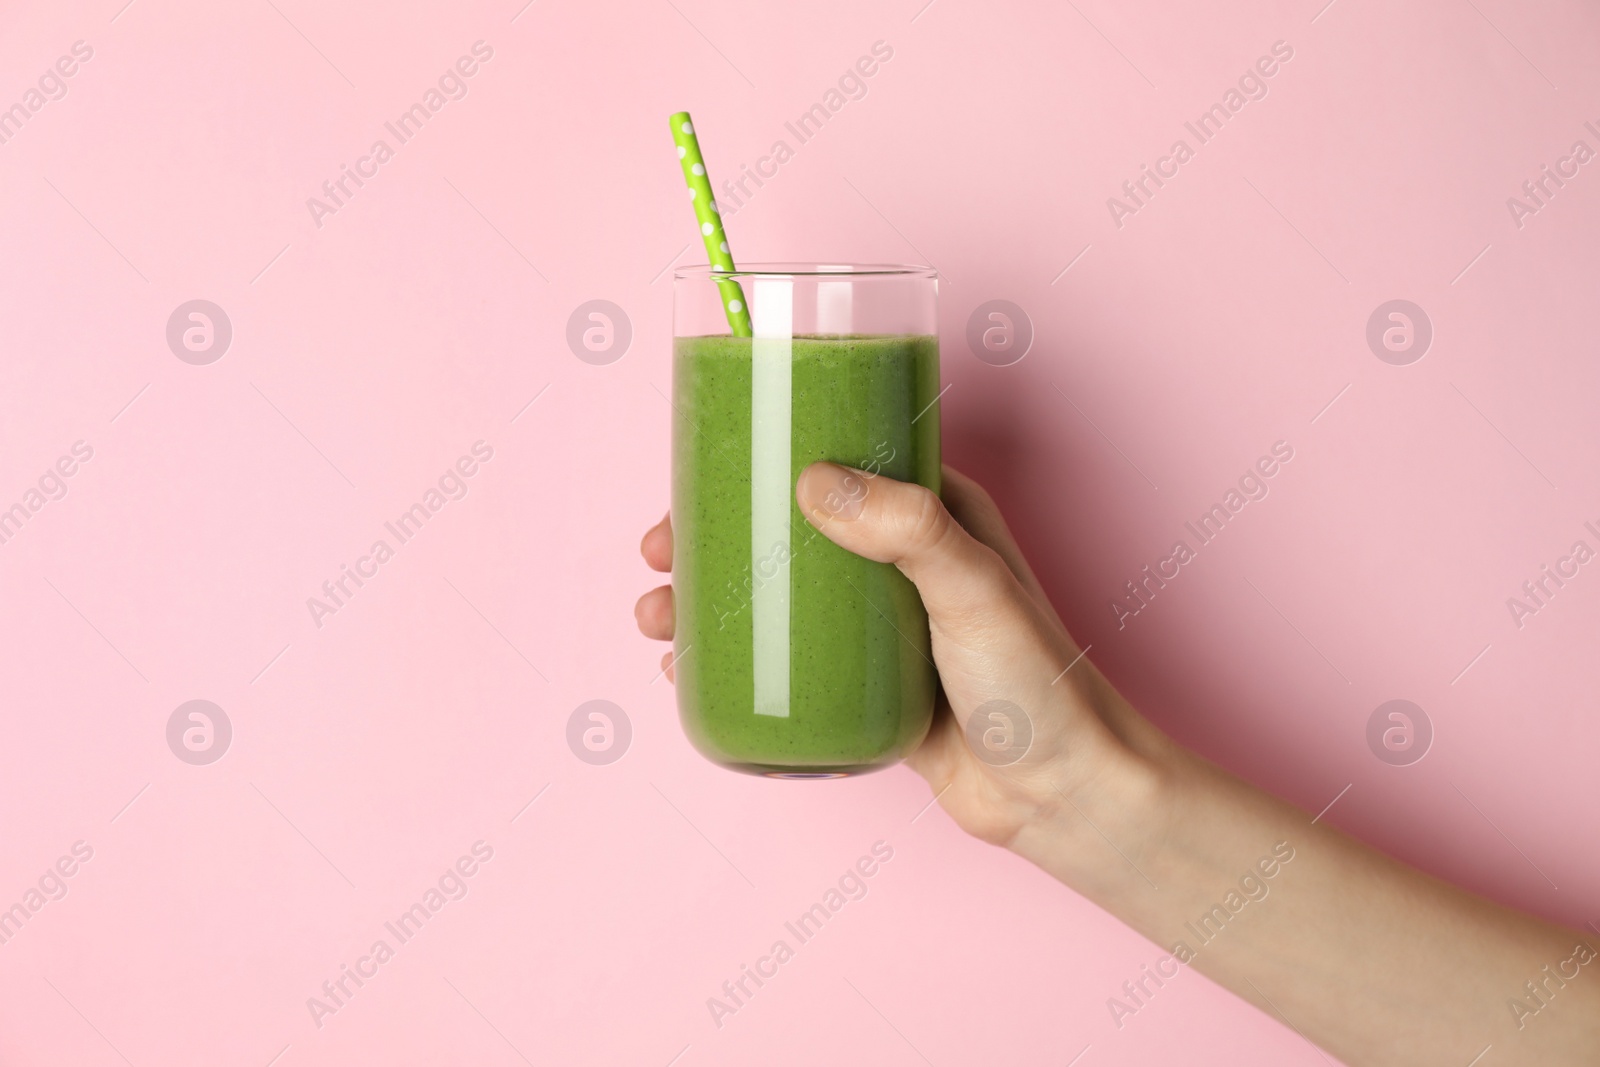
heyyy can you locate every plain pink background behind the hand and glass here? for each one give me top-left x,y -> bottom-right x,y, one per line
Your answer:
0,0 -> 1600,1067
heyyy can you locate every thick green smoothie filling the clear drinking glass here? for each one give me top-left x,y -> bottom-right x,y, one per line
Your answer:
672,336 -> 939,777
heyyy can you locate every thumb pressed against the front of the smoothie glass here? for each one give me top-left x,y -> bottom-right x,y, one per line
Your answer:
795,462 -> 1027,640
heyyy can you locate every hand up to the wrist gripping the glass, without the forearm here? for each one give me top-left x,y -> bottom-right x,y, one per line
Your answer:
635,462 -> 1165,845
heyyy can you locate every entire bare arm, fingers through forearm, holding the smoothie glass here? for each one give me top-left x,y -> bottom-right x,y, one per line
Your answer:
637,464 -> 1600,1067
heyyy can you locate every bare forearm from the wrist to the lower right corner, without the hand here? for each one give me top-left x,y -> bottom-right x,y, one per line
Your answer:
1013,710 -> 1600,1067
